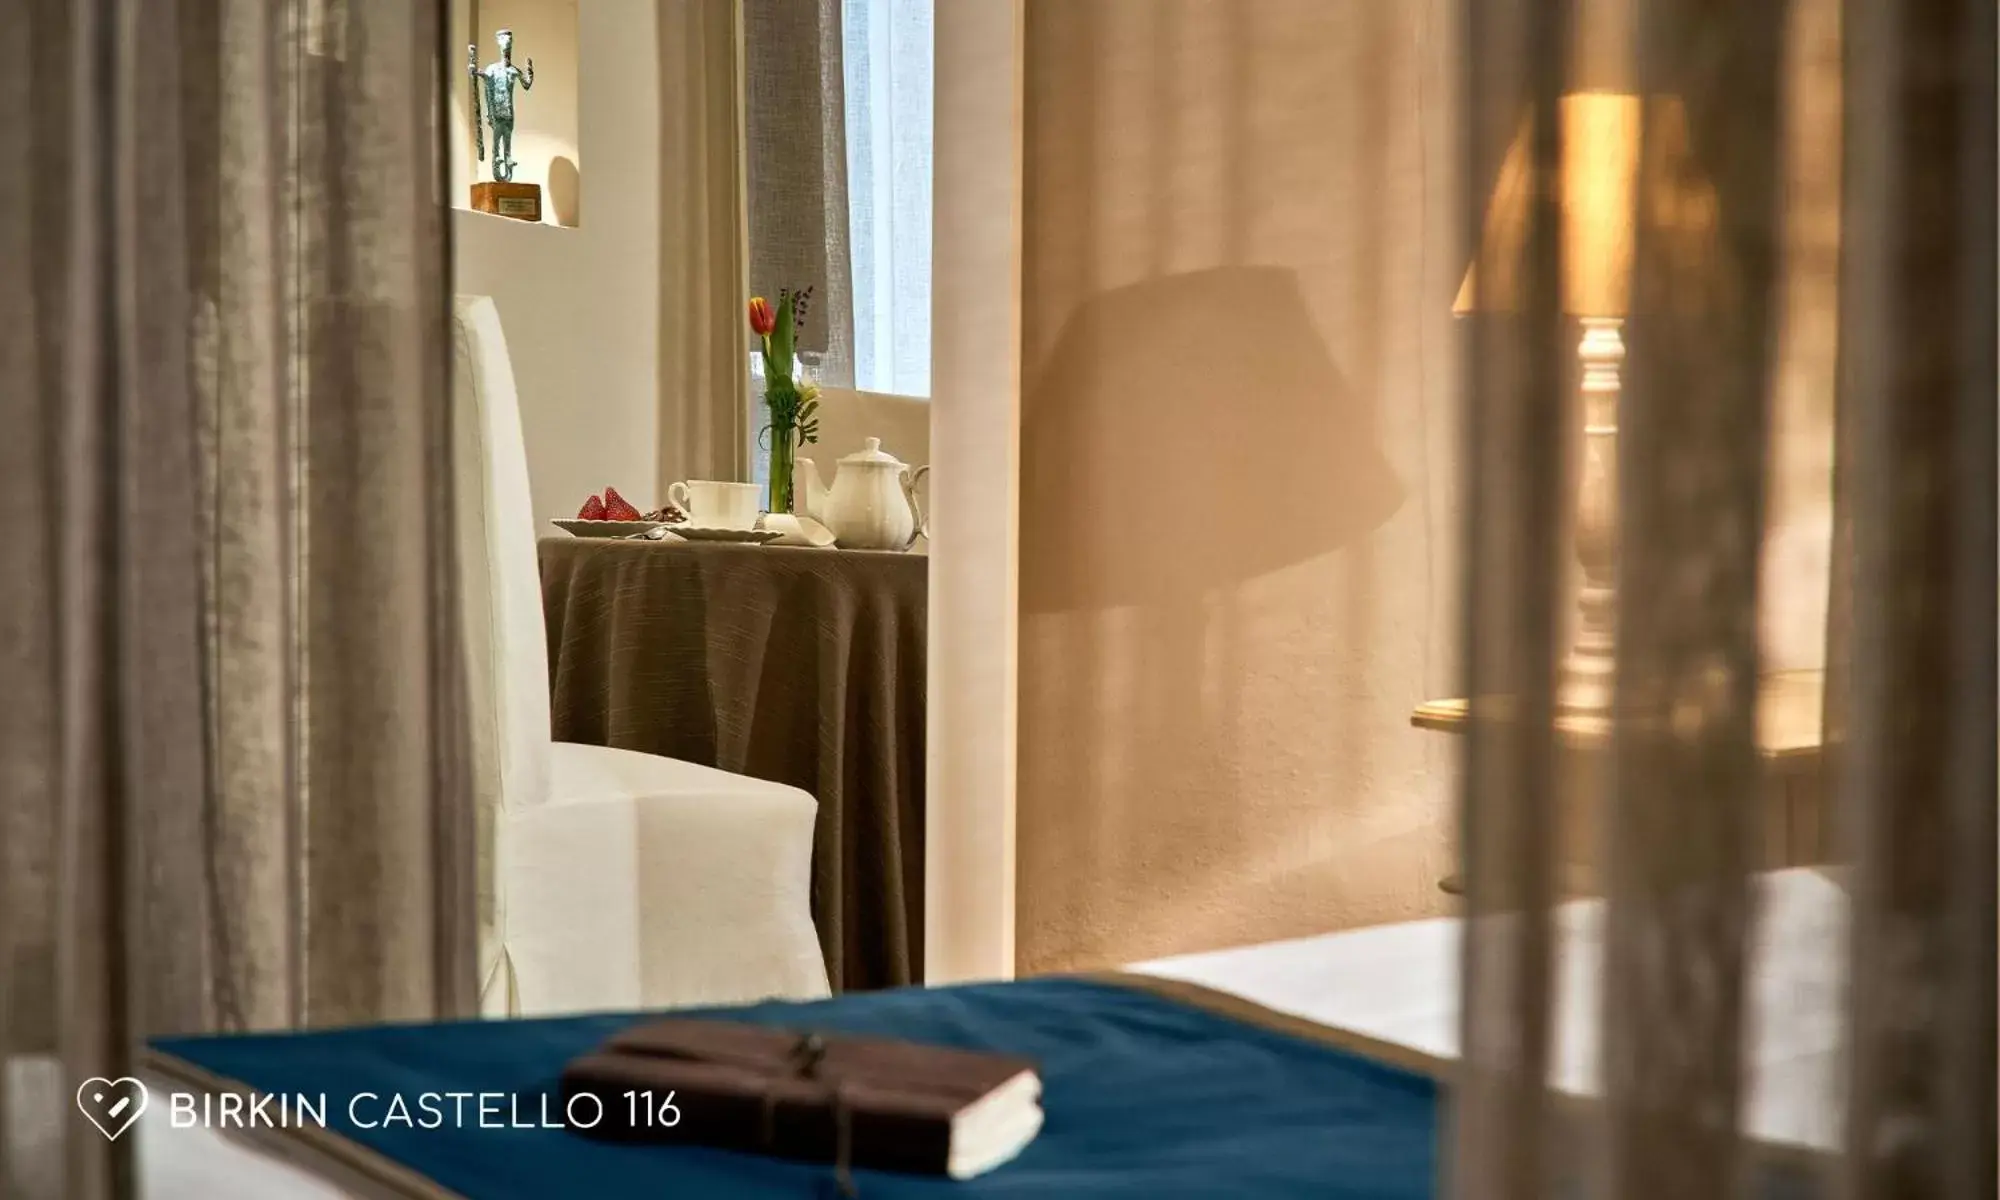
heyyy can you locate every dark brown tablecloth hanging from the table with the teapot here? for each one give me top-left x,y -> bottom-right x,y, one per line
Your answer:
540,538 -> 928,990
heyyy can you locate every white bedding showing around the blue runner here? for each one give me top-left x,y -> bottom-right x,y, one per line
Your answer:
121,870 -> 1846,1200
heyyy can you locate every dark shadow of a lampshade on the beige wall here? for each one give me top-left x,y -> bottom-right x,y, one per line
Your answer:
1022,266 -> 1404,612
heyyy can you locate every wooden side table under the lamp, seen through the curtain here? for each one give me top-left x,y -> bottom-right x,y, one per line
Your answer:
1410,670 -> 1828,896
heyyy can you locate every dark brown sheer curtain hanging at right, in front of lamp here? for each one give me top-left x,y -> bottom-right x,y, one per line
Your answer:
1450,0 -> 1996,1200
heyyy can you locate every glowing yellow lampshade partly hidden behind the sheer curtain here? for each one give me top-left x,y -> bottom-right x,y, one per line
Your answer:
1452,92 -> 1640,316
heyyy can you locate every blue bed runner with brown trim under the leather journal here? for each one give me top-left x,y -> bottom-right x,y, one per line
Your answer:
154,978 -> 1438,1200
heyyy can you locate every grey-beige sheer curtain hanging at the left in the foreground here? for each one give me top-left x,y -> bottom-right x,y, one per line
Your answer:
0,0 -> 476,1198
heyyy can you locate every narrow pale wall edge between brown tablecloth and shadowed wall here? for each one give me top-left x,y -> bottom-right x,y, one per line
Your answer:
924,0 -> 1026,984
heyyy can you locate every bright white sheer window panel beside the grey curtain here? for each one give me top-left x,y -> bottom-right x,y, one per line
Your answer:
840,0 -> 934,396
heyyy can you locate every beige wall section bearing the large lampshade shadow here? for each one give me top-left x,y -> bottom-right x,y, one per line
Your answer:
1018,0 -> 1462,970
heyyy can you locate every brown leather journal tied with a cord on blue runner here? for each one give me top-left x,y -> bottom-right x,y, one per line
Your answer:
562,1020 -> 1042,1178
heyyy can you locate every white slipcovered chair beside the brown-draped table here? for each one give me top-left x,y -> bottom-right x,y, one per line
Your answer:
454,296 -> 828,1016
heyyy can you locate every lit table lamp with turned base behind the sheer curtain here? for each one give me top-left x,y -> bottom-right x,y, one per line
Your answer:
1452,92 -> 1640,712
